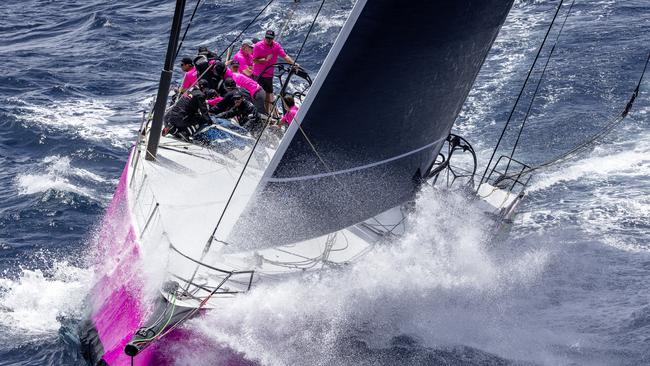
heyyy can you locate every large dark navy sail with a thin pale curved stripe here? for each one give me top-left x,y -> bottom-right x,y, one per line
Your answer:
230,0 -> 513,245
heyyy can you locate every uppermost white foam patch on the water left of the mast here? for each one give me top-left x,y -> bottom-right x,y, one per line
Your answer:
10,98 -> 137,148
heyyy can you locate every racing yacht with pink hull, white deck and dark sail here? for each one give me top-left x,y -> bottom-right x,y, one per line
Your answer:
80,0 -> 521,365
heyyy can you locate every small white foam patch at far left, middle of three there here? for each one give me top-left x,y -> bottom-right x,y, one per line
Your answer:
16,155 -> 108,201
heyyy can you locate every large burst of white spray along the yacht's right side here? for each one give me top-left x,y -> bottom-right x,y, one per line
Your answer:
182,190 -> 548,365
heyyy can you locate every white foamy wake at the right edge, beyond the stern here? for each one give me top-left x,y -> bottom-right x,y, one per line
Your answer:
520,131 -> 650,252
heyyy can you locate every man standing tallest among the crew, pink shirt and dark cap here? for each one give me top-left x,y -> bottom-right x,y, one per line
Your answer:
253,30 -> 298,112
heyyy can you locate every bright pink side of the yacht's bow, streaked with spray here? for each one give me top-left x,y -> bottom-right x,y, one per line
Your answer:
89,153 -> 256,366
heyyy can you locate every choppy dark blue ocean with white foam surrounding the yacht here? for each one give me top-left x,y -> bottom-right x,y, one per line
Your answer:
0,0 -> 650,365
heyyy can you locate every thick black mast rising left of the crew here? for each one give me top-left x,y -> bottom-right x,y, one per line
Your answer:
145,0 -> 185,161
